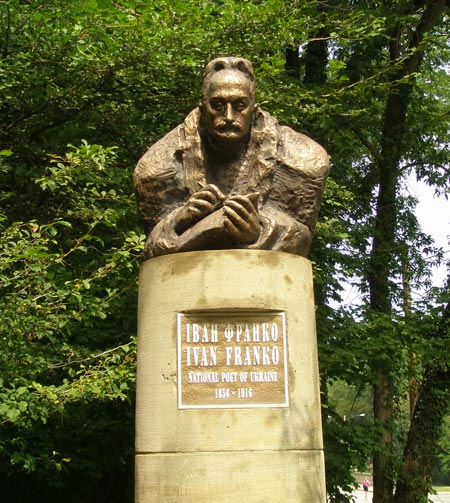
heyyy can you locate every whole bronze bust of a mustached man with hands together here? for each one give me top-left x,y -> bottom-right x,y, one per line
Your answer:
134,57 -> 329,258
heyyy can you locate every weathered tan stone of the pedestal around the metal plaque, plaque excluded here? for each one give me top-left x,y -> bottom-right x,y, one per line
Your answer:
136,250 -> 325,503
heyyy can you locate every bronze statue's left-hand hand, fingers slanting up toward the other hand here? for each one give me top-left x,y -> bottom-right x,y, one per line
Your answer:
174,184 -> 225,234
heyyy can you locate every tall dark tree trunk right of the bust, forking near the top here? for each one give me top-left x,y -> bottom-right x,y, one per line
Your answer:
369,0 -> 445,503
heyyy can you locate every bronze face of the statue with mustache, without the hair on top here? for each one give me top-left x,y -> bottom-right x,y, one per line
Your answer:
202,70 -> 254,144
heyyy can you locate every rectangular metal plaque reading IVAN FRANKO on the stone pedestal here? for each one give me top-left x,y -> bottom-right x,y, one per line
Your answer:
177,311 -> 289,409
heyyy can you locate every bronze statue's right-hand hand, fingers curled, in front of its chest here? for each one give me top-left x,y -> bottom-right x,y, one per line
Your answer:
224,193 -> 261,243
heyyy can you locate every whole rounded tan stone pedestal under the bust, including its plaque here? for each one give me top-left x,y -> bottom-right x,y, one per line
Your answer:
136,250 -> 326,503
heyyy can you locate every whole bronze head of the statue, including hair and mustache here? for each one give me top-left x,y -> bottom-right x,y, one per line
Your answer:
201,57 -> 255,146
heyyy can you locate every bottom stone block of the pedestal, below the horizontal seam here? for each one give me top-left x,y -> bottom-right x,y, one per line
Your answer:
136,451 -> 326,503
